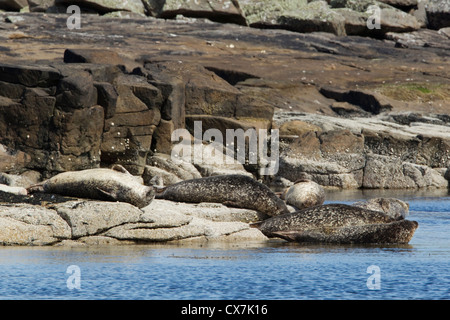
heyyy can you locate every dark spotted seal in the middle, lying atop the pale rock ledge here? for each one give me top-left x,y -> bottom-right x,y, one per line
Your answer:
156,174 -> 289,216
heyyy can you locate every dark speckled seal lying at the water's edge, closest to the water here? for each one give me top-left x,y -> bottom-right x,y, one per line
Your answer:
252,204 -> 418,243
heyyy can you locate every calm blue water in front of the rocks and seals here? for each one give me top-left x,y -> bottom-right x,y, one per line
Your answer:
0,190 -> 450,300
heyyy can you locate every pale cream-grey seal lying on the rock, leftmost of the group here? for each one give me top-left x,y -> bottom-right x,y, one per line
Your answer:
27,165 -> 155,208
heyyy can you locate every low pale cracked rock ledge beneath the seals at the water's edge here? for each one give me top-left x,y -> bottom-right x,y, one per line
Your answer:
0,191 -> 268,246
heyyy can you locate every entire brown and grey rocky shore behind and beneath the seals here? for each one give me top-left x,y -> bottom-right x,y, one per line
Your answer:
0,0 -> 450,245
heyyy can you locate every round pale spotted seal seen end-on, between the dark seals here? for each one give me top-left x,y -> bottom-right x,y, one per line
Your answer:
284,179 -> 325,210
